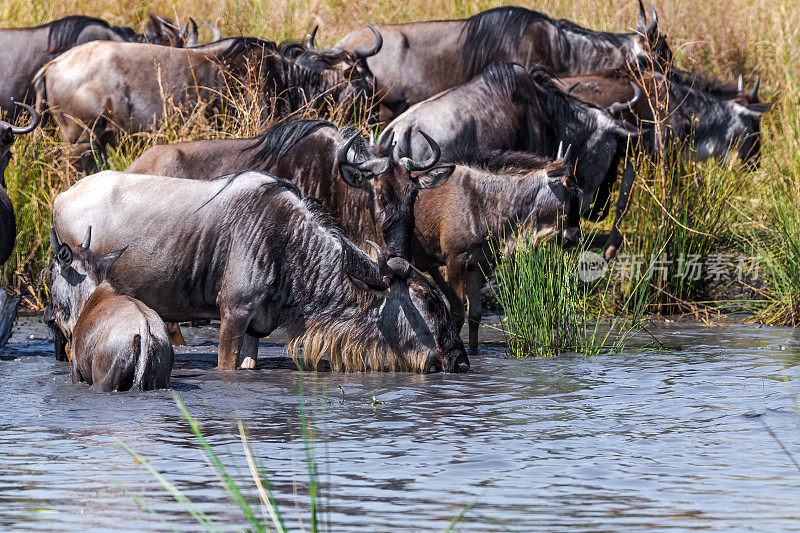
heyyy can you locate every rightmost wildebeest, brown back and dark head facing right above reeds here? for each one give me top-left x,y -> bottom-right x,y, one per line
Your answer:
558,69 -> 772,166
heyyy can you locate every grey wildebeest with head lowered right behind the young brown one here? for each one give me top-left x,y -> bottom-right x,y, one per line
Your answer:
378,62 -> 639,258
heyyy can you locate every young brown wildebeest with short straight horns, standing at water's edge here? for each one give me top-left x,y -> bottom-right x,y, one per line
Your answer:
412,149 -> 580,354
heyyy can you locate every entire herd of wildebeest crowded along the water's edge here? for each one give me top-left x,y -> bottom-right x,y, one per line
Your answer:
0,1 -> 770,391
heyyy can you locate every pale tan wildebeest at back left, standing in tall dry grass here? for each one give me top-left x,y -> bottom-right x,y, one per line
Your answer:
39,28 -> 382,170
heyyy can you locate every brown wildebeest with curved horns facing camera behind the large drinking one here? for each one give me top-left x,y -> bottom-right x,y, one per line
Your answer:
125,119 -> 453,258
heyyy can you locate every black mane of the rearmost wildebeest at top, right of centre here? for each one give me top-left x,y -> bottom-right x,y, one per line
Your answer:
461,6 -> 552,77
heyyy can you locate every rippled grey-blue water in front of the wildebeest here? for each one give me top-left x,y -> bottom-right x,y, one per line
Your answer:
0,318 -> 800,532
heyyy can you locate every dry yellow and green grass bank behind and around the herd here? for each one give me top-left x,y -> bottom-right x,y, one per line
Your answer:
0,0 -> 800,325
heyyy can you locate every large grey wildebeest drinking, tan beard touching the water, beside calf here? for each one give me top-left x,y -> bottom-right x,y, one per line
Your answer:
53,171 -> 469,372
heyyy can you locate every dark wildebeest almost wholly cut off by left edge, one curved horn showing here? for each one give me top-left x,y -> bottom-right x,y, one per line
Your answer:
0,102 -> 41,346
